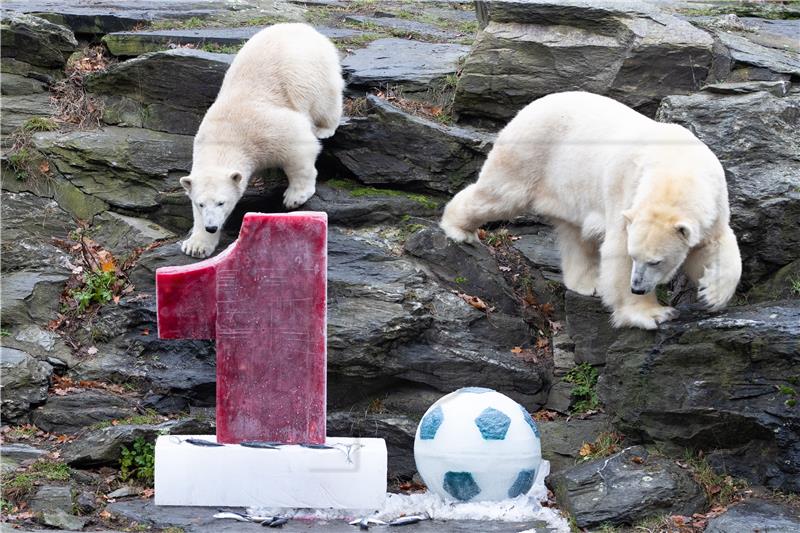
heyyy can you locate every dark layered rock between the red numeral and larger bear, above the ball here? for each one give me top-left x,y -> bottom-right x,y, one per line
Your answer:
328,228 -> 550,409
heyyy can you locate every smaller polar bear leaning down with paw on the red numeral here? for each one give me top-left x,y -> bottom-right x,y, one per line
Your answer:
180,24 -> 344,257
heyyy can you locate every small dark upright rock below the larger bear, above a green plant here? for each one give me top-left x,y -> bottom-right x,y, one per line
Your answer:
564,290 -> 619,366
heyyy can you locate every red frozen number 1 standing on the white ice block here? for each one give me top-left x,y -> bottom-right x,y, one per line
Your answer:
156,212 -> 328,444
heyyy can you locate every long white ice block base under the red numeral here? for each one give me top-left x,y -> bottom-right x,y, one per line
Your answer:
155,435 -> 387,509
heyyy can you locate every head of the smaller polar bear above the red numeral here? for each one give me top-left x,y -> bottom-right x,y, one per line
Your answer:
180,168 -> 246,233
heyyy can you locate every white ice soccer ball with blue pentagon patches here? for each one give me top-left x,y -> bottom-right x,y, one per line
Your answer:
414,387 -> 542,501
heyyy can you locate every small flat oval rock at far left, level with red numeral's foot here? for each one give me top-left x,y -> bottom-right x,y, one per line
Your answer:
31,389 -> 136,434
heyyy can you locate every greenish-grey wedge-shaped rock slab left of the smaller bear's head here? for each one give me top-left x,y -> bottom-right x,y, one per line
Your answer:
34,126 -> 197,218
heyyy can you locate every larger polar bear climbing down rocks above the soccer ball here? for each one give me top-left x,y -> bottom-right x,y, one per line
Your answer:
441,92 -> 742,329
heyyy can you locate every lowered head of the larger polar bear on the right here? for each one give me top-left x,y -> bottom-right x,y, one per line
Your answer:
623,207 -> 699,294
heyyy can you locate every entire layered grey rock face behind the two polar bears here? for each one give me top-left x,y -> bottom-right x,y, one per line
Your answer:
0,0 -> 800,531
